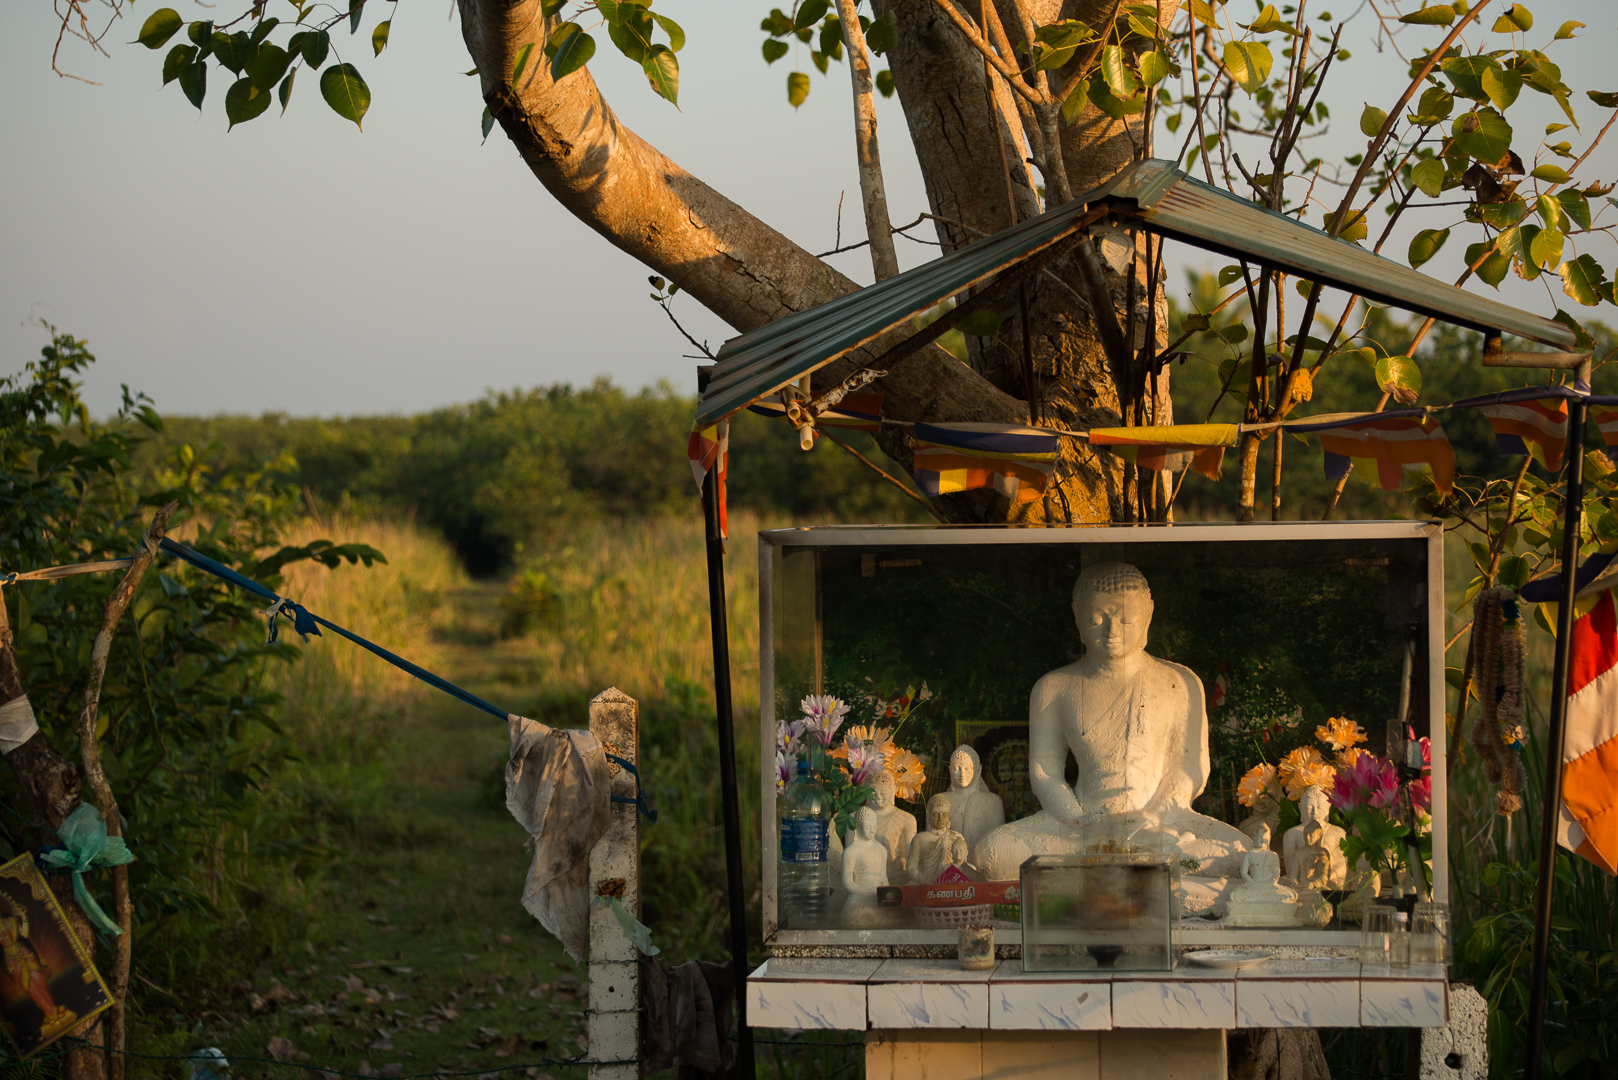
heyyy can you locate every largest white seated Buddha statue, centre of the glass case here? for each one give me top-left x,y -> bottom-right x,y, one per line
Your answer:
972,562 -> 1251,915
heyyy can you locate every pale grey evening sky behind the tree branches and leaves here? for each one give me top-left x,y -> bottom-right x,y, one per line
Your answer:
0,0 -> 1618,416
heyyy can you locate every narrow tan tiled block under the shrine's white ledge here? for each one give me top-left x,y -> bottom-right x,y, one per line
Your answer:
866,1030 -> 1225,1080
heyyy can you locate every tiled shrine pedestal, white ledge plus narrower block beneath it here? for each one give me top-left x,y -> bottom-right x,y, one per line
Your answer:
748,957 -> 1448,1080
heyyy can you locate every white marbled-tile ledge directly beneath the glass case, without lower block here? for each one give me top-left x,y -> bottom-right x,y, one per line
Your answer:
748,957 -> 1450,1036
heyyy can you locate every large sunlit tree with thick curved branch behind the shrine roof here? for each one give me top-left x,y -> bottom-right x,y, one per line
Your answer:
72,0 -> 1618,521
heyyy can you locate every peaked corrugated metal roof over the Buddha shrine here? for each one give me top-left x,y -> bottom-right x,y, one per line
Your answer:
697,159 -> 1574,426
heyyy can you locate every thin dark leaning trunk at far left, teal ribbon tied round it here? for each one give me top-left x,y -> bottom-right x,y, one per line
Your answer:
0,591 -> 107,1080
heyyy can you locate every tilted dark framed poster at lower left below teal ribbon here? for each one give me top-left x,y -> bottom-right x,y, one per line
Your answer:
0,855 -> 112,1059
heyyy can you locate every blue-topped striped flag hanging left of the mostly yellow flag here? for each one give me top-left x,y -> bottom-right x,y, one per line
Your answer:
911,424 -> 1061,502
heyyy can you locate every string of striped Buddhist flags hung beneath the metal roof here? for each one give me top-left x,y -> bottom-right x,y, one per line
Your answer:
688,385 -> 1618,511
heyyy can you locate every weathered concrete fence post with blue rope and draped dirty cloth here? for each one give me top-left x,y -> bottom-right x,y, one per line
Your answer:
587,687 -> 641,1080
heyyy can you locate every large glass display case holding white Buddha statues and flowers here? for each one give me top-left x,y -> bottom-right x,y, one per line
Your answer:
759,521 -> 1448,967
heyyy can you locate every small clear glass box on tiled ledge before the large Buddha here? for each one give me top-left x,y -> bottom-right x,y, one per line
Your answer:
1023,853 -> 1176,972
